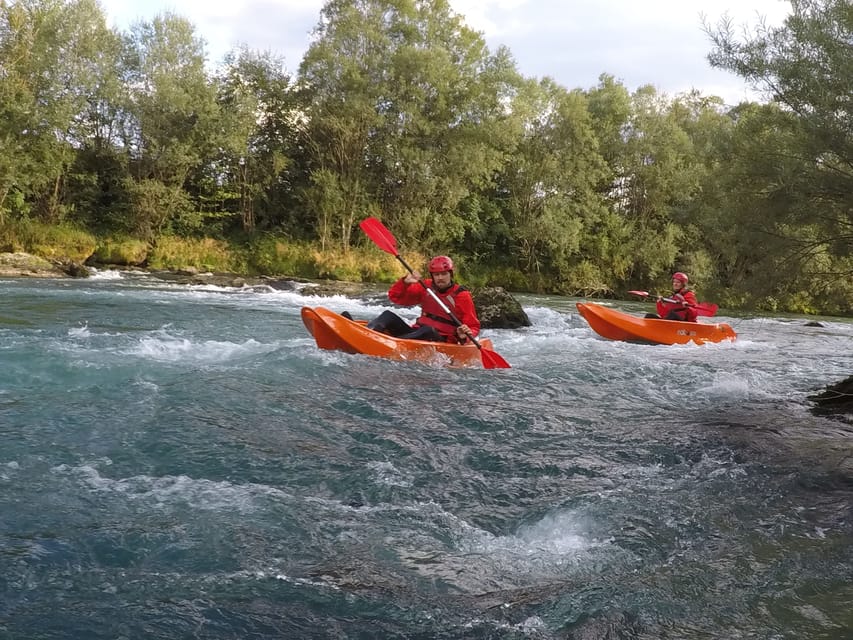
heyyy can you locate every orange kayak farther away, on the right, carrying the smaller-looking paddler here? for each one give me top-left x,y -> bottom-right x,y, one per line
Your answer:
577,302 -> 737,344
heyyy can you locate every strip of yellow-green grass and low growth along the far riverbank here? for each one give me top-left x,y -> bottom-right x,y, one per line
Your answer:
5,220 -> 853,316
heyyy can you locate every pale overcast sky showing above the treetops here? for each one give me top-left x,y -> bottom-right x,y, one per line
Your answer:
101,0 -> 790,104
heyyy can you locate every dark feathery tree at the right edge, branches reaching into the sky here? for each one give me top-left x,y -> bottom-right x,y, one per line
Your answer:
706,0 -> 853,313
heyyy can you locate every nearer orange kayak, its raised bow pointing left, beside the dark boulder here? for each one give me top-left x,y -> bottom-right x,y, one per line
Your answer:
302,307 -> 493,367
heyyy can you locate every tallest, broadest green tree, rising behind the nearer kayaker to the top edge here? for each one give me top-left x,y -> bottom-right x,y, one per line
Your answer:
300,0 -> 516,252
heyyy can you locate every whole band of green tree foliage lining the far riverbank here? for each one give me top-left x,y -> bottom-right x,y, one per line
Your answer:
0,0 -> 853,313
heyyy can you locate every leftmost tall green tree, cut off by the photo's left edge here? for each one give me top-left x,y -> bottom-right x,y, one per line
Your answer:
0,0 -> 114,222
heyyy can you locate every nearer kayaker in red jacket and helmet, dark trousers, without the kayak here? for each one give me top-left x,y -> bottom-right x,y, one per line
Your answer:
367,256 -> 480,343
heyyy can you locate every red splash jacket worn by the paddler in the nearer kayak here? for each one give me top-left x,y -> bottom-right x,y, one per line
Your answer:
388,278 -> 480,343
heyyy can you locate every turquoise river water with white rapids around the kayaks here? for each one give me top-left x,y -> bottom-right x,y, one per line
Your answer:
0,272 -> 853,640
